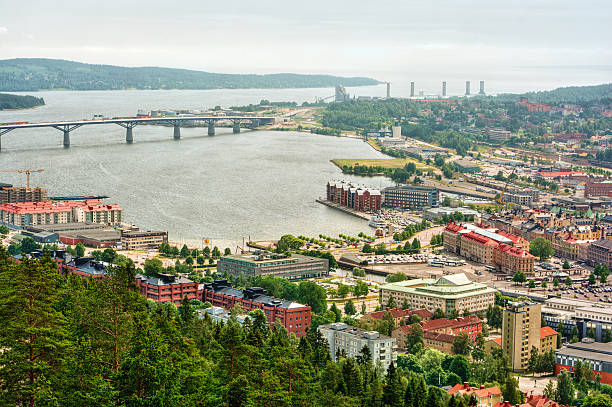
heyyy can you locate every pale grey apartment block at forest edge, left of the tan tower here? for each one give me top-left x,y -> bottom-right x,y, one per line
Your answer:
318,322 -> 397,371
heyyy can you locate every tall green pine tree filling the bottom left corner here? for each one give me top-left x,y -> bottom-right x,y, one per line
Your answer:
0,255 -> 67,406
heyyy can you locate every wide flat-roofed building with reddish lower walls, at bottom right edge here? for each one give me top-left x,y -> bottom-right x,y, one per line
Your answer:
555,338 -> 612,385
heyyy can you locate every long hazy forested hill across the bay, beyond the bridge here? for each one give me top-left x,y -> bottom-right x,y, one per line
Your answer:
0,58 -> 380,92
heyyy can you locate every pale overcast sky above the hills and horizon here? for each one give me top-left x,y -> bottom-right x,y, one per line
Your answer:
0,0 -> 612,76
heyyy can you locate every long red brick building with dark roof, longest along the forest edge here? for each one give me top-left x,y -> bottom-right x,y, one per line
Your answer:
202,280 -> 310,337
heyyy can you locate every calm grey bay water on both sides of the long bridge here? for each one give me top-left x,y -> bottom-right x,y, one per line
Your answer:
0,89 -> 396,249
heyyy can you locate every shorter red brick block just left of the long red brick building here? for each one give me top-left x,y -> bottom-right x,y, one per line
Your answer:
136,274 -> 201,305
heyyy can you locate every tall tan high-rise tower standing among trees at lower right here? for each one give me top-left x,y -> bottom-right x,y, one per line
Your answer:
502,302 -> 542,372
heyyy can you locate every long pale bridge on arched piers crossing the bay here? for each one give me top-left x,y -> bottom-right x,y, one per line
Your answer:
0,115 -> 274,148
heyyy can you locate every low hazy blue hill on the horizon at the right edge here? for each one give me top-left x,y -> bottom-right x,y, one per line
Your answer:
498,83 -> 612,103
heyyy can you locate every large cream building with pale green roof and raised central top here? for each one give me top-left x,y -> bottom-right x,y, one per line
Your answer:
380,273 -> 495,315
